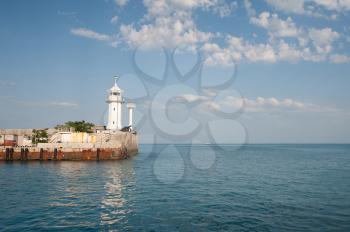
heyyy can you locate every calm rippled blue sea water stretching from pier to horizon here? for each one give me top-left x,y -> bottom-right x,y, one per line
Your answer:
0,145 -> 350,231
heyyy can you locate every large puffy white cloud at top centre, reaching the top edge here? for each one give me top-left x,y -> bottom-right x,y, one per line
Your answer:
120,0 -> 213,49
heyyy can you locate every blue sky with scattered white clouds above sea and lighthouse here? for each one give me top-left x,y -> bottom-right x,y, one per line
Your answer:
0,0 -> 350,143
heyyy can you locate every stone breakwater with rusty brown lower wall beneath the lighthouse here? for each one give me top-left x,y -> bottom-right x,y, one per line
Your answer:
0,132 -> 138,161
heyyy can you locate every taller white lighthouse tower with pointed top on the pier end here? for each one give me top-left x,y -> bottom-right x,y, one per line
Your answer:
106,77 -> 124,130
